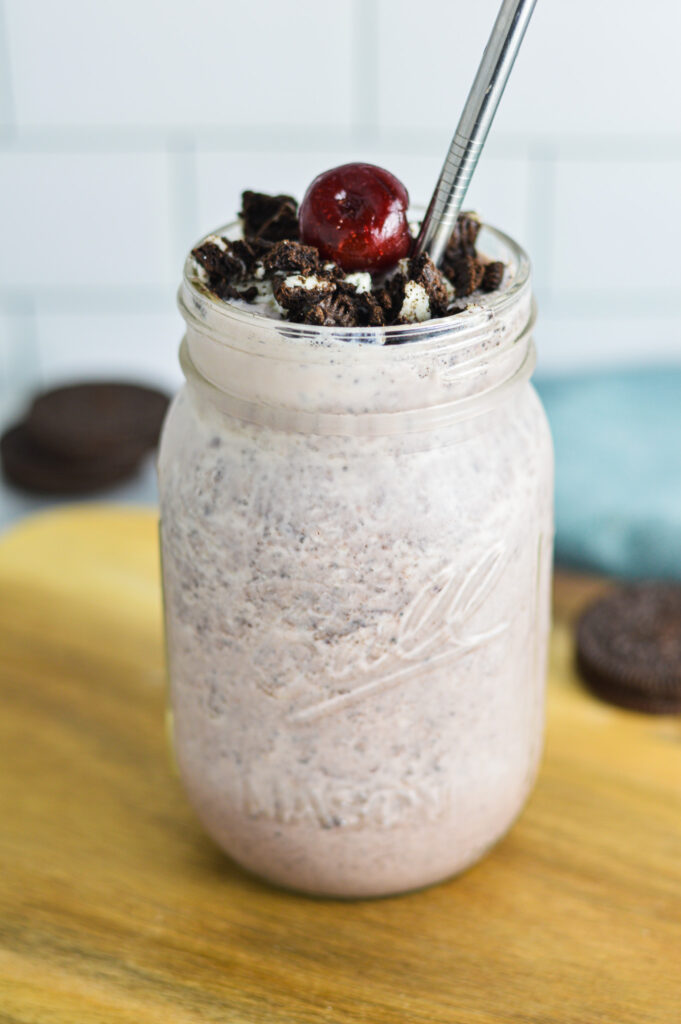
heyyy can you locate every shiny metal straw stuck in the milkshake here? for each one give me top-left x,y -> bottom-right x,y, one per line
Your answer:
415,0 -> 537,264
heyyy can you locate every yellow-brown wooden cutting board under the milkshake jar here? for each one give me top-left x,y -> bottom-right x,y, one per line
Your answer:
0,507 -> 681,1024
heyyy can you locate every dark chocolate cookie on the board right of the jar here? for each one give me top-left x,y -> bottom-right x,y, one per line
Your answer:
577,583 -> 681,715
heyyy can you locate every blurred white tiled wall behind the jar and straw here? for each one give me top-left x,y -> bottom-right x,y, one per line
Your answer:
0,0 -> 681,569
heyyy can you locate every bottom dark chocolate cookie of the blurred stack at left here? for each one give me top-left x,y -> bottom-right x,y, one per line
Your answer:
0,423 -> 146,496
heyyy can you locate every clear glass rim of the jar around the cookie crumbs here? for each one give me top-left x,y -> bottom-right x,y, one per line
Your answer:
178,221 -> 531,361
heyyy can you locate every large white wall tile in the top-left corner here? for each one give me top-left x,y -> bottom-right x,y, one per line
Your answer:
5,0 -> 352,127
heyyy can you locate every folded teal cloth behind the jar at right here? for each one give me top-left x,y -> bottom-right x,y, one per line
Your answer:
537,367 -> 681,580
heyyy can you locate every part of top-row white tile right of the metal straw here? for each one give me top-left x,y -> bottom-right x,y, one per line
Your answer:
496,0 -> 681,138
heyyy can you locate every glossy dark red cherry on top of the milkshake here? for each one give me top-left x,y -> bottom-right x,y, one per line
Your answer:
298,164 -> 412,273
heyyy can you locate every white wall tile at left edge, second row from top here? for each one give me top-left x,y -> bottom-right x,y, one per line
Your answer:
0,152 -> 171,288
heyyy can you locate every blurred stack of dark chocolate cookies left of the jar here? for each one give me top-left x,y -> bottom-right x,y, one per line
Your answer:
0,381 -> 169,496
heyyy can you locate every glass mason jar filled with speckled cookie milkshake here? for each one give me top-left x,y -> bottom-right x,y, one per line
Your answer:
160,227 -> 553,897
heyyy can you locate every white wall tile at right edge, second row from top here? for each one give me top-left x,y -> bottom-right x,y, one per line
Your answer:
551,160 -> 681,292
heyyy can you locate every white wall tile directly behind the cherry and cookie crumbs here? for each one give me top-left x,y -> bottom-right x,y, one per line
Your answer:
193,144 -> 529,243
